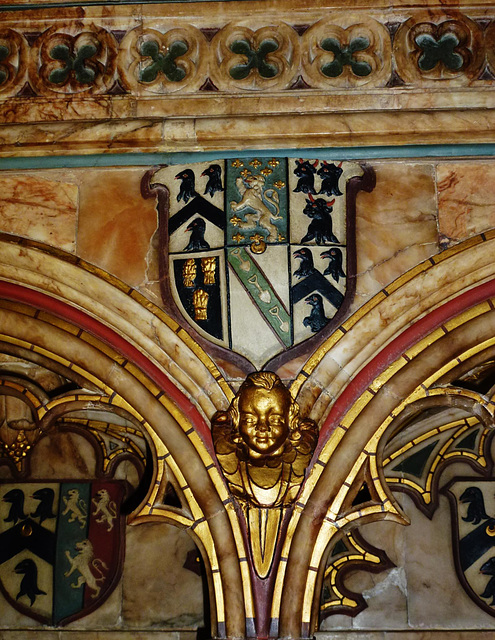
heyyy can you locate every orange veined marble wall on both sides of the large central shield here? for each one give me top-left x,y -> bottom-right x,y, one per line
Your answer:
0,159 -> 495,364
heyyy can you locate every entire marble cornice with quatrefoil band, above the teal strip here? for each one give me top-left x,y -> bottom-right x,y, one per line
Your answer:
0,0 -> 495,156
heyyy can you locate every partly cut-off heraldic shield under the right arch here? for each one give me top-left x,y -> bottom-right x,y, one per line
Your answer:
444,478 -> 495,616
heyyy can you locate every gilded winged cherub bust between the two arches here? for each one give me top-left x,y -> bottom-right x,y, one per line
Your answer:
212,372 -> 317,508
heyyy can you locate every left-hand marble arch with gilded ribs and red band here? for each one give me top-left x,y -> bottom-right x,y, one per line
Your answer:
0,237 -> 253,636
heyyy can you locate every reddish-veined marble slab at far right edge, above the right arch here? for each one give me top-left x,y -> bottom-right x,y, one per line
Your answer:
437,160 -> 495,246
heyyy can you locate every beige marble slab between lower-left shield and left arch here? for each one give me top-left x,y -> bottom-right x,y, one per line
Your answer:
123,523 -> 203,629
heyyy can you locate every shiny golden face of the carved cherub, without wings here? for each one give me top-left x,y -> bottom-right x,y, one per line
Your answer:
239,387 -> 291,457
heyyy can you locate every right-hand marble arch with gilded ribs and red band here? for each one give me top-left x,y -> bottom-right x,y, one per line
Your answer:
273,233 -> 495,637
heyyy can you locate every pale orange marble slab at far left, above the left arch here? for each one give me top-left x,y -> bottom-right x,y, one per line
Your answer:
0,173 -> 78,252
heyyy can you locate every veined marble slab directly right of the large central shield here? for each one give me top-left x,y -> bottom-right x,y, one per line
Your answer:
353,163 -> 438,308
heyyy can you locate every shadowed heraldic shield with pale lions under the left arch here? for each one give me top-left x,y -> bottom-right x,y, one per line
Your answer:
0,480 -> 124,626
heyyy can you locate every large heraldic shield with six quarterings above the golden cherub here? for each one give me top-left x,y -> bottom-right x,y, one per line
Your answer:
150,157 -> 364,368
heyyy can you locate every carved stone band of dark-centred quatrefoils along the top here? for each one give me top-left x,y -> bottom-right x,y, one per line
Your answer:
0,11 -> 494,97
